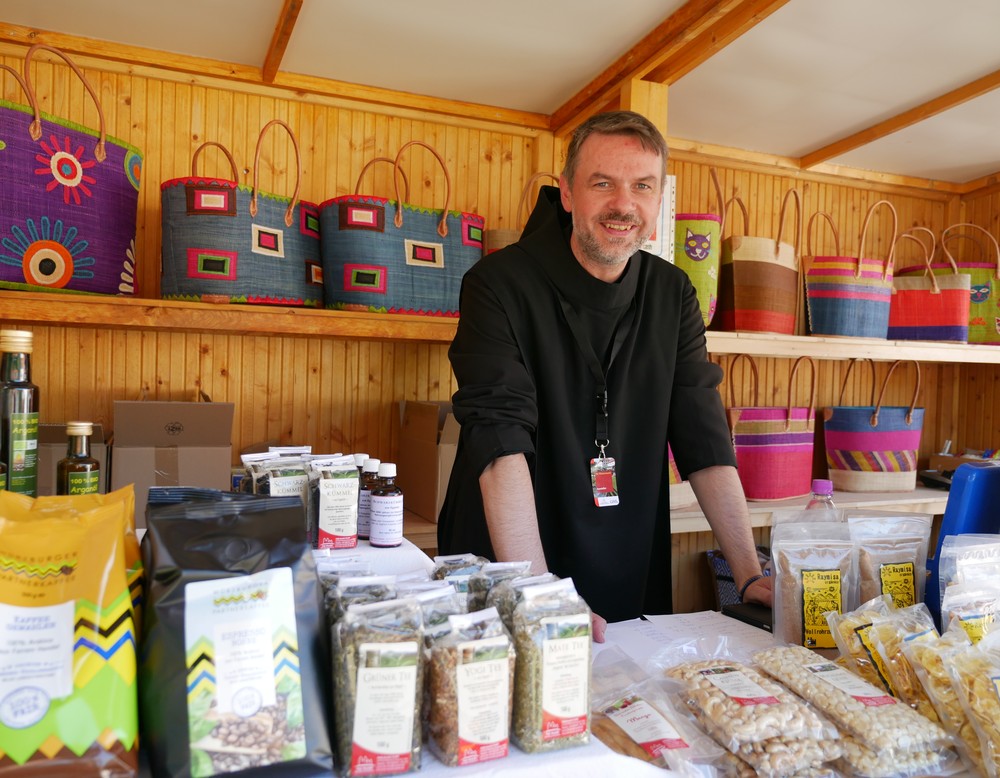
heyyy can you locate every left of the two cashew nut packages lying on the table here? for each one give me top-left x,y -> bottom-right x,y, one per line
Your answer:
666,659 -> 841,777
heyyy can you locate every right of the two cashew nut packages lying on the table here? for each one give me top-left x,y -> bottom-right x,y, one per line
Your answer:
753,646 -> 950,761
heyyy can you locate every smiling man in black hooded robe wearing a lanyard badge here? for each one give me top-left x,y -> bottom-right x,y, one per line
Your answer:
438,111 -> 771,640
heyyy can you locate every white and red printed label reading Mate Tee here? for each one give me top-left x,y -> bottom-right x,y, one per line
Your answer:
541,613 -> 590,741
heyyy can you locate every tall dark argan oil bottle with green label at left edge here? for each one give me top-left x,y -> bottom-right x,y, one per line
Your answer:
0,330 -> 40,497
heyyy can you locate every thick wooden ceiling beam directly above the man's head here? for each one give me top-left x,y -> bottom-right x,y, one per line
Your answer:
549,0 -> 788,135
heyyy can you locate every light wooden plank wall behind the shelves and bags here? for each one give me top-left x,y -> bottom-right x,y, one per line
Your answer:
0,43 -> 1000,610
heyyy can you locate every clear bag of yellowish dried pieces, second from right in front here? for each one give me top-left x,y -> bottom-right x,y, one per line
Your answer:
902,629 -> 986,775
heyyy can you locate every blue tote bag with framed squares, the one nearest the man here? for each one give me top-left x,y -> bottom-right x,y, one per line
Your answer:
320,141 -> 485,316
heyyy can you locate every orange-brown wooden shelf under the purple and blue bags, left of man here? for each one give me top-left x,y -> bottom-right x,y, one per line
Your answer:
0,290 -> 458,343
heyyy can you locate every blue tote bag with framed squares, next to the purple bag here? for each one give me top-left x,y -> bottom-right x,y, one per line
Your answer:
160,119 -> 323,308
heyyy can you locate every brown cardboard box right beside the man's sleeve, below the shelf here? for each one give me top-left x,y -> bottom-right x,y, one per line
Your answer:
396,401 -> 461,522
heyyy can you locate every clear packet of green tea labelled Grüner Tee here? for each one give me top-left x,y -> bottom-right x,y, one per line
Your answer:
333,599 -> 424,778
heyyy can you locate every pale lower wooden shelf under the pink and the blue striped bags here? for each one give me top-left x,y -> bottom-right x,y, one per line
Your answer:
670,486 -> 948,533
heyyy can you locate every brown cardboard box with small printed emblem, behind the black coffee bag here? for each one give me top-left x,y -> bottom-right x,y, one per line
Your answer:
111,400 -> 233,527
